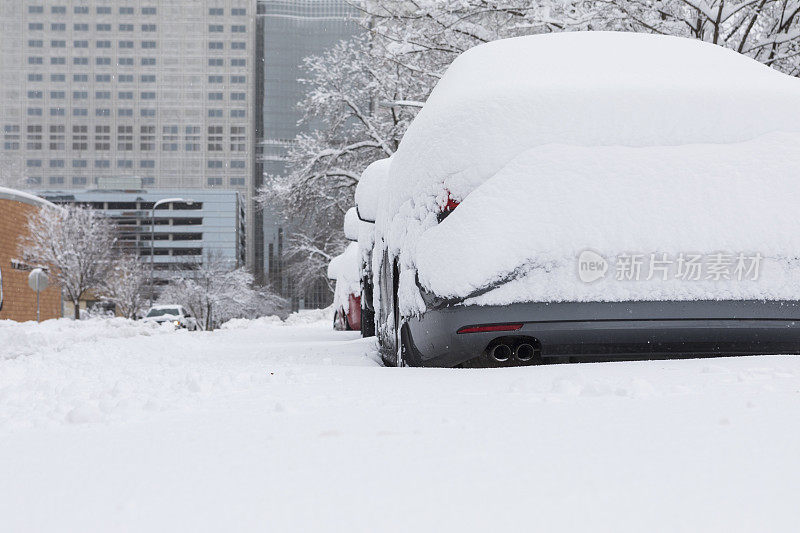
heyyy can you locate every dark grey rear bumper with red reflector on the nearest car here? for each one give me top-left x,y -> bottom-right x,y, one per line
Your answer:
406,301 -> 800,367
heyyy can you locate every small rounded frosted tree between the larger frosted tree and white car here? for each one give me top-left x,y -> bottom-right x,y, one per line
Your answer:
101,254 -> 150,319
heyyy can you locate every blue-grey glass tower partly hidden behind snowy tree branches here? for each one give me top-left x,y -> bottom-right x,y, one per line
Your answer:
255,0 -> 360,308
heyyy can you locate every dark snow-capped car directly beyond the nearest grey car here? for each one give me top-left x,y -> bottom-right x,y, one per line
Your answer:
355,158 -> 391,337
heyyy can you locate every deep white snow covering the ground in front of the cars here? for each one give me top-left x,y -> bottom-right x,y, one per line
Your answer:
0,317 -> 800,532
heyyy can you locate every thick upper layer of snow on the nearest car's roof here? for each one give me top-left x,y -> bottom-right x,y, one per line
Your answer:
387,32 -> 800,219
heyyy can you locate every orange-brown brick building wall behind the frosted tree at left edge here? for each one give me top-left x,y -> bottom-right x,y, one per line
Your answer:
0,198 -> 61,322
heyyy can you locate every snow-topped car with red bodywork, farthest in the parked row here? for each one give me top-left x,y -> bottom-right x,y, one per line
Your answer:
328,242 -> 361,331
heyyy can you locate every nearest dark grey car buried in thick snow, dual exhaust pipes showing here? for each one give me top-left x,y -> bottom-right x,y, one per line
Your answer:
373,32 -> 800,366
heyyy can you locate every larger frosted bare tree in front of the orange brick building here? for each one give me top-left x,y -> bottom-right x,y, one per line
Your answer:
18,206 -> 117,319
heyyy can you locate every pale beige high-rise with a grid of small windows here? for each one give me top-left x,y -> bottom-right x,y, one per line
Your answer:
0,0 -> 261,271
